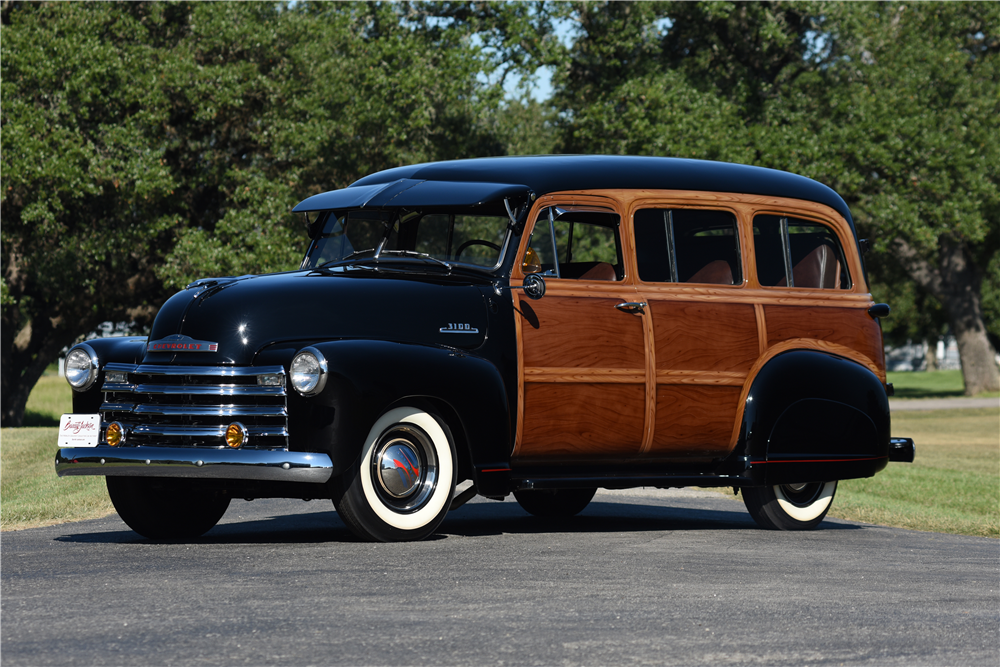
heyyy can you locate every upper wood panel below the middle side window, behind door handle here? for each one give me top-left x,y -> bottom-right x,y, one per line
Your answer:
640,302 -> 760,374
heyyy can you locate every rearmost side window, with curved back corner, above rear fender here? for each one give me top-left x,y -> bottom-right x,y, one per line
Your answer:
753,215 -> 851,289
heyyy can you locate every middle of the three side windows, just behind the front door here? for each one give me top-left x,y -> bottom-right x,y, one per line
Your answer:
634,208 -> 743,285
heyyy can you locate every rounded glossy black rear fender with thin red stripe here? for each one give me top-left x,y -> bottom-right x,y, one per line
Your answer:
740,350 -> 890,485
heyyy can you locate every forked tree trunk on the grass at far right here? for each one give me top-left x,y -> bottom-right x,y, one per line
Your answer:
896,236 -> 1000,396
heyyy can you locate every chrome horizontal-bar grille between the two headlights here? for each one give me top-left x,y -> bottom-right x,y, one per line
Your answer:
101,364 -> 288,449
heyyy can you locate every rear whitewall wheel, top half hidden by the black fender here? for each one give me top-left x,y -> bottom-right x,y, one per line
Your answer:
742,480 -> 837,530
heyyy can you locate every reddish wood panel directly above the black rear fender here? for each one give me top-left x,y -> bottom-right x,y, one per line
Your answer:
764,305 -> 885,374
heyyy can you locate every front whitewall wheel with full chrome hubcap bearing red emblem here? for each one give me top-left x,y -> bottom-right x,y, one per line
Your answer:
334,407 -> 457,542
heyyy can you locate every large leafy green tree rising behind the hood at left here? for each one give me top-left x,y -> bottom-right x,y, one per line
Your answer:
0,2 -> 505,426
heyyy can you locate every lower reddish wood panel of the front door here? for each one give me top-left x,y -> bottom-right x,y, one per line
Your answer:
515,382 -> 645,463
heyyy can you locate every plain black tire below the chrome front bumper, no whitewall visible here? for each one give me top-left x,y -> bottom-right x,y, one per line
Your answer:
105,477 -> 229,540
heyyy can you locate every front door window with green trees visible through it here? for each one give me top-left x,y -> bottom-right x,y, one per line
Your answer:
521,207 -> 624,281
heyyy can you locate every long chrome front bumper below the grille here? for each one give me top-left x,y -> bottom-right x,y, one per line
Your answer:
56,445 -> 333,484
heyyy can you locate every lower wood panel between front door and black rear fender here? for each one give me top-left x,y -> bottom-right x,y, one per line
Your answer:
648,386 -> 742,458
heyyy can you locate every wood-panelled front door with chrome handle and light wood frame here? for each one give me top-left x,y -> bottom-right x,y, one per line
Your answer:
512,196 -> 652,465
